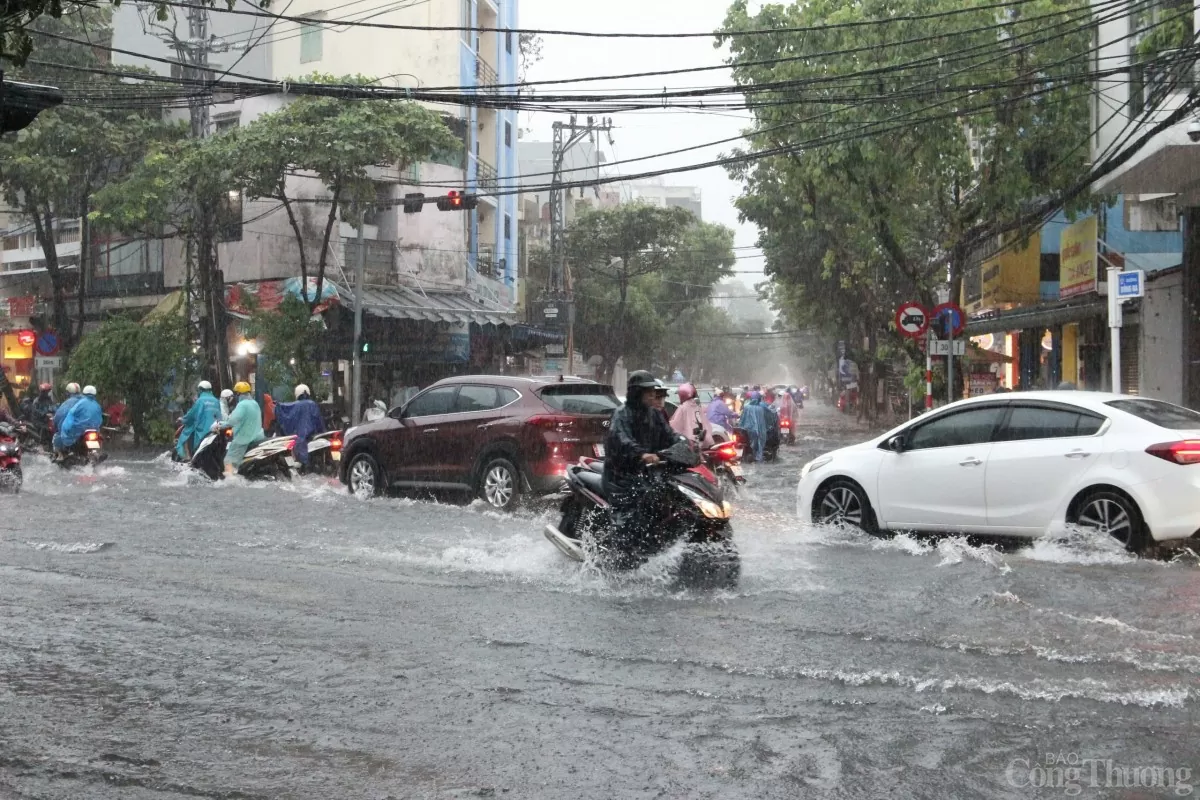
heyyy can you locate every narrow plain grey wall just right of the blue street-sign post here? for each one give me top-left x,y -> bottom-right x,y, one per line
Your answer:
1138,272 -> 1183,404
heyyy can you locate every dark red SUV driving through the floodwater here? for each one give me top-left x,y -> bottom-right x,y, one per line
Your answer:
340,375 -> 619,509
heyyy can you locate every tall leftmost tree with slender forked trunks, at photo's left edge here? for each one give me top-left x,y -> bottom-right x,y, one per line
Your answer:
0,8 -> 180,351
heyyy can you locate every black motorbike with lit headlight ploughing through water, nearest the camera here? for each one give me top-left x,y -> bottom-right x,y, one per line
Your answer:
544,443 -> 742,589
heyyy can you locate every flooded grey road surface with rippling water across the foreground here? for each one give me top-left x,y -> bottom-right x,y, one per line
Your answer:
0,409 -> 1200,800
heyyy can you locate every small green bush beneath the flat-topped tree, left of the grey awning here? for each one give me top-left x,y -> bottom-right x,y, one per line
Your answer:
246,295 -> 325,397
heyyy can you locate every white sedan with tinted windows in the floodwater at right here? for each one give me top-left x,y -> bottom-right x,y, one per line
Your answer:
798,391 -> 1200,552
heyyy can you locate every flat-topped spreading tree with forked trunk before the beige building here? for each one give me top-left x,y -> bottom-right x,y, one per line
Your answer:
230,74 -> 463,308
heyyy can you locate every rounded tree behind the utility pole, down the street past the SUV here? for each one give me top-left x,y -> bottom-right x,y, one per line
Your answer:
566,203 -> 733,381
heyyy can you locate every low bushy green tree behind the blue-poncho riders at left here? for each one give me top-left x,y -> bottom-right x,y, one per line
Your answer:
66,314 -> 188,443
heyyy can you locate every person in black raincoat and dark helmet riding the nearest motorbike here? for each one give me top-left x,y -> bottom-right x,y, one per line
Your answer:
604,369 -> 683,556
